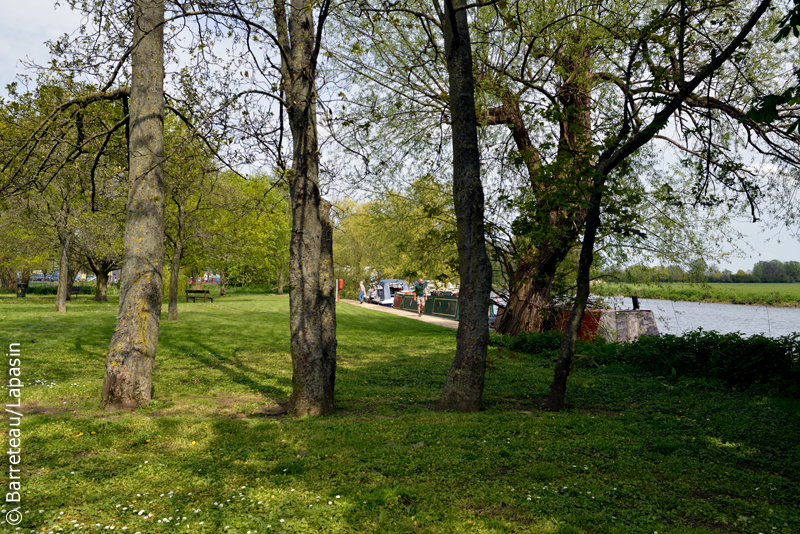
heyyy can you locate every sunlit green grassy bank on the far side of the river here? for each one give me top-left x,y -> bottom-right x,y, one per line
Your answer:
592,283 -> 800,308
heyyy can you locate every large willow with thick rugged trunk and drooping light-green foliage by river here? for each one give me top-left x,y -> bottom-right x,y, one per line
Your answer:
328,0 -> 791,340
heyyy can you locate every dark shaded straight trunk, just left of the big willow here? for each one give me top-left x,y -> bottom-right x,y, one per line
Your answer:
437,0 -> 492,412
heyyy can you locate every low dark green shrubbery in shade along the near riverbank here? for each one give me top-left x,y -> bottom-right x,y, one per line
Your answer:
491,329 -> 800,397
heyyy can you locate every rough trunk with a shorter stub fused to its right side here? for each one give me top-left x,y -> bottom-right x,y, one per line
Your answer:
275,0 -> 336,417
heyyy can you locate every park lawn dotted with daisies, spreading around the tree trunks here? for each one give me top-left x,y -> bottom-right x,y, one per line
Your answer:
0,295 -> 800,534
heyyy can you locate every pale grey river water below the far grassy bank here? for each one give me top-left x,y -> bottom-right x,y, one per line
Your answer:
604,297 -> 800,337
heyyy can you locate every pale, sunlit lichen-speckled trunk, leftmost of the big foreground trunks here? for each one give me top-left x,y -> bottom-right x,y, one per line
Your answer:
102,0 -> 164,409
